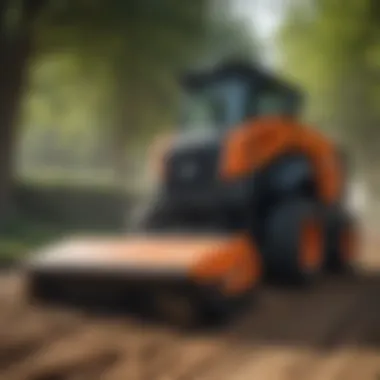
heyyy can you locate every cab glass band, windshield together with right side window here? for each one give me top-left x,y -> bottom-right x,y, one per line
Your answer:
180,79 -> 299,133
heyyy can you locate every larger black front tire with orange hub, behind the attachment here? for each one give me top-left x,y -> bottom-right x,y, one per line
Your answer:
264,199 -> 325,285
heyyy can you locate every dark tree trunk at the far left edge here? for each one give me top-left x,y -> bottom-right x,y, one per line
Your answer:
0,0 -> 46,215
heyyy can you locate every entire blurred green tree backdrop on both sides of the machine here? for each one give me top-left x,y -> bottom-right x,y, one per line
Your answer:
0,0 -> 380,240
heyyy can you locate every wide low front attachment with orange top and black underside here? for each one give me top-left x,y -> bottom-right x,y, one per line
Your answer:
24,235 -> 261,326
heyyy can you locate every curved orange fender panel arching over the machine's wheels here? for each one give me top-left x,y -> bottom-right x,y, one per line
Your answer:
221,117 -> 342,203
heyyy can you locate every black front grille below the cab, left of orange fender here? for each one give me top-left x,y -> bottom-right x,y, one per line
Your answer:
166,146 -> 219,193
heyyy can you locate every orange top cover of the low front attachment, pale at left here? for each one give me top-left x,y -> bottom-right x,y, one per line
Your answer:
32,235 -> 261,294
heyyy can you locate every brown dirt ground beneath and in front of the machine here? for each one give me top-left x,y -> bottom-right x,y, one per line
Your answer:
0,224 -> 380,380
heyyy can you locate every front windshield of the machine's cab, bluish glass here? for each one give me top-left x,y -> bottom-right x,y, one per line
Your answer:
181,81 -> 247,131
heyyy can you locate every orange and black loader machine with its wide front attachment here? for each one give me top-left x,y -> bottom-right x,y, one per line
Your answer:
23,62 -> 356,321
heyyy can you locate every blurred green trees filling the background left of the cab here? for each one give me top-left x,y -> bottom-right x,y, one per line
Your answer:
0,0 -> 255,208
